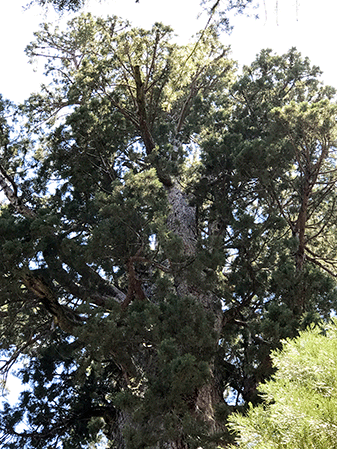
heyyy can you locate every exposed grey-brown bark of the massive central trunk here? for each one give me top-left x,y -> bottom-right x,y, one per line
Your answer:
105,180 -> 224,449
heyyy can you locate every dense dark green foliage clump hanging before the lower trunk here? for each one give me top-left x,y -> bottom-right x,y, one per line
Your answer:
111,297 -> 214,447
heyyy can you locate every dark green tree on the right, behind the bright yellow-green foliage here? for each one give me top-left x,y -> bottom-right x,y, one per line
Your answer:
196,49 -> 336,401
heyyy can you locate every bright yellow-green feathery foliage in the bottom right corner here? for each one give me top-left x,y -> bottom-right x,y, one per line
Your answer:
230,322 -> 337,449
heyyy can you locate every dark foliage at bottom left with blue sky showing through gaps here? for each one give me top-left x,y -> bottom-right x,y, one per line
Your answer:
1,333 -> 118,449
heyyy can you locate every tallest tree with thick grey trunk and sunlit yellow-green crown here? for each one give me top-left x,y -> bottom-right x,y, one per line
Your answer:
2,15 -> 232,447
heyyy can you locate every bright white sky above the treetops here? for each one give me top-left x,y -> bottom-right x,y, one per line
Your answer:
0,0 -> 337,102
